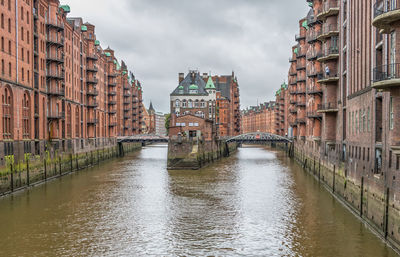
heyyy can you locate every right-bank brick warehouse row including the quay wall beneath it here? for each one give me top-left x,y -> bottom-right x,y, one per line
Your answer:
277,0 -> 400,248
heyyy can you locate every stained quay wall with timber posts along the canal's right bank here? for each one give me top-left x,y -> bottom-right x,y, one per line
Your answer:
281,141 -> 400,251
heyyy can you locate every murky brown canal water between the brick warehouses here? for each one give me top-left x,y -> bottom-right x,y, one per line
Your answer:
0,145 -> 396,257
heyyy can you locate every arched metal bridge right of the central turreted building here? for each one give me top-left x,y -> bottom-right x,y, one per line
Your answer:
227,132 -> 292,144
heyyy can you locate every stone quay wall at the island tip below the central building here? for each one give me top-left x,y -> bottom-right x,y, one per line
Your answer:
167,138 -> 238,170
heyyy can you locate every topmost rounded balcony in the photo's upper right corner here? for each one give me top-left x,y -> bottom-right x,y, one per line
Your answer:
372,0 -> 400,33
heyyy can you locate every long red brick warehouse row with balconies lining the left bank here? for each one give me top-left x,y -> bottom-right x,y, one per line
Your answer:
0,0 -> 143,161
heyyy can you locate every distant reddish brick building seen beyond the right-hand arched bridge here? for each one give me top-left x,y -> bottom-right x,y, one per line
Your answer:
242,101 -> 278,134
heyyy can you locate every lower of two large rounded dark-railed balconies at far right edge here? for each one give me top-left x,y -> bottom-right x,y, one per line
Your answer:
372,63 -> 400,90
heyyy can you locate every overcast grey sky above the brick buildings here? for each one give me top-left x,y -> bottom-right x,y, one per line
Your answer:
61,0 -> 309,112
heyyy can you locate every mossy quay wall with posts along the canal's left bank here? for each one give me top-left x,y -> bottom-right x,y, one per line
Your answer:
0,143 -> 142,197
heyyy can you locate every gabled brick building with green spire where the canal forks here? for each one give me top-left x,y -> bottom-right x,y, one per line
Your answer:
170,71 -> 241,140
